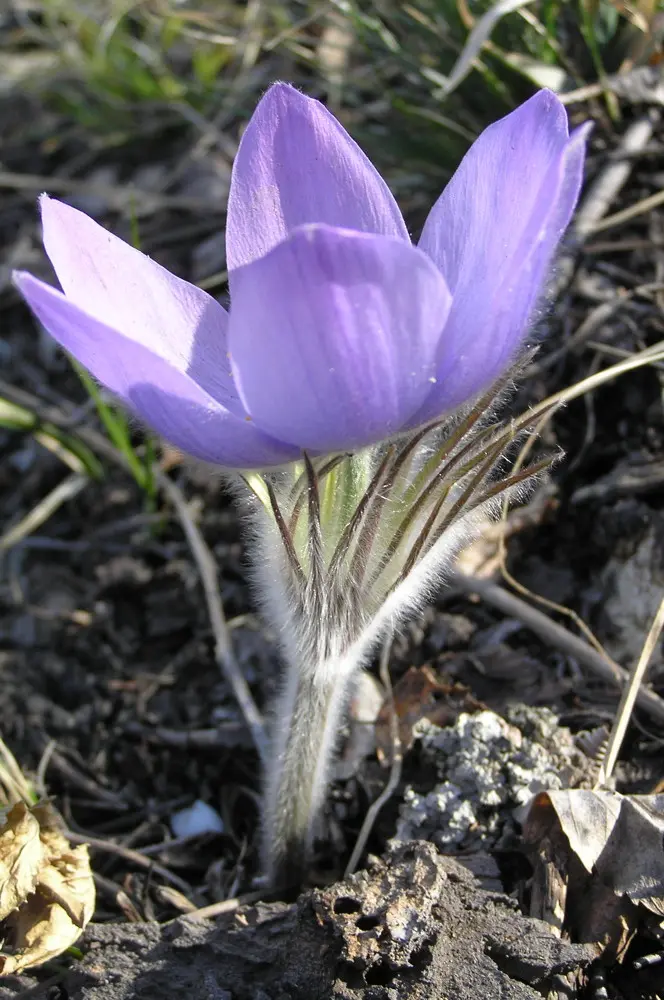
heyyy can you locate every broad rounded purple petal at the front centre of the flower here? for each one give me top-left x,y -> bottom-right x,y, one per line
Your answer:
229,225 -> 450,451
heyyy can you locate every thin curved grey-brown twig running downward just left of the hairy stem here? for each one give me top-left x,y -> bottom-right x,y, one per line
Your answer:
157,473 -> 267,761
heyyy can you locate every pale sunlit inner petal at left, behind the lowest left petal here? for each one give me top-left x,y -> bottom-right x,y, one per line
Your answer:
41,195 -> 238,410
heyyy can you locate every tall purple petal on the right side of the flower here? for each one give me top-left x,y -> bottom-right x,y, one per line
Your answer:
417,91 -> 587,421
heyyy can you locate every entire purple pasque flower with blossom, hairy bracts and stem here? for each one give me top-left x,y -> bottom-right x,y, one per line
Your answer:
16,84 -> 587,880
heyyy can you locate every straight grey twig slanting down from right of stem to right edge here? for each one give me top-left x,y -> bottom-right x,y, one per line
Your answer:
451,574 -> 664,722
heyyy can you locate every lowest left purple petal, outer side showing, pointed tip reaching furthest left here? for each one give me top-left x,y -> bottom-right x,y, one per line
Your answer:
14,271 -> 298,469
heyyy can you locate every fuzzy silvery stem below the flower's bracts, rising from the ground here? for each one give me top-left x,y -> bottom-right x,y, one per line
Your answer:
263,662 -> 350,885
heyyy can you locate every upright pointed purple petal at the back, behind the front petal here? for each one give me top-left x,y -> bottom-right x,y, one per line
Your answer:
226,83 -> 410,270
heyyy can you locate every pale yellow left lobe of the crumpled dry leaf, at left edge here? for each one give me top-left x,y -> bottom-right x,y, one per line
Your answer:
0,802 -> 43,920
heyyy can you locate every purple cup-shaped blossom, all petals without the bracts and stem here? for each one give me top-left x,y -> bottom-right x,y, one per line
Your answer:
15,84 -> 587,468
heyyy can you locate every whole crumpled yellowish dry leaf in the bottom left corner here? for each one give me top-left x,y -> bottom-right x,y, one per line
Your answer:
0,802 -> 95,975
